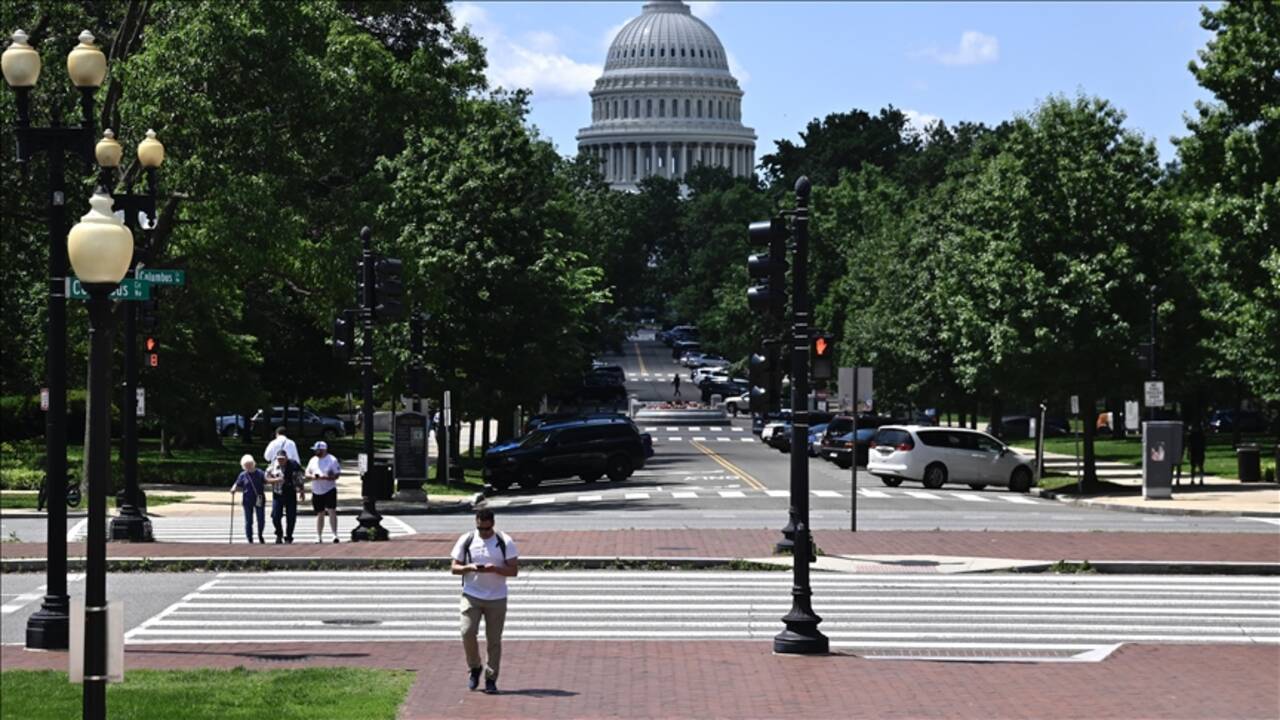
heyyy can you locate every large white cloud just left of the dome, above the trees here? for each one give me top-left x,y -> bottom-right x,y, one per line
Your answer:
449,3 -> 603,99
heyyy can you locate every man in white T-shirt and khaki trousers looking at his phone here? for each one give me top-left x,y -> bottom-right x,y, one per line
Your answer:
452,507 -> 520,694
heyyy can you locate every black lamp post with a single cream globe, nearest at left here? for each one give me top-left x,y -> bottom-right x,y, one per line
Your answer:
67,188 -> 133,720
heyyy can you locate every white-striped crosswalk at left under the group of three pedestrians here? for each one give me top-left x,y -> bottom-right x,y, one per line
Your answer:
67,507 -> 415,544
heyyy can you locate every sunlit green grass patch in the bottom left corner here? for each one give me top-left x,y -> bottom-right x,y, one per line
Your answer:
0,667 -> 413,720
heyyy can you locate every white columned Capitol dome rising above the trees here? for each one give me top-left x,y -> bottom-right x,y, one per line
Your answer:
577,0 -> 755,191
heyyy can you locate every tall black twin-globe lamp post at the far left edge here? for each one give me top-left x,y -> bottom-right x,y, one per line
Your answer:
0,29 -> 106,650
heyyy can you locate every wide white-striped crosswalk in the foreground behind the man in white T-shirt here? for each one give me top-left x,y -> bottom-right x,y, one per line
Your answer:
125,570 -> 1280,661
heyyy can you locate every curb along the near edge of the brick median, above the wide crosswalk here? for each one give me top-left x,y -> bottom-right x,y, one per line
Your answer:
0,556 -> 1280,577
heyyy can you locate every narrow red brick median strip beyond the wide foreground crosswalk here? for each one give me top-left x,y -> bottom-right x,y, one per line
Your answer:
0,525 -> 1280,562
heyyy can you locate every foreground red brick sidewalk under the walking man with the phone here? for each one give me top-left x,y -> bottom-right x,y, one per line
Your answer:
0,635 -> 1280,720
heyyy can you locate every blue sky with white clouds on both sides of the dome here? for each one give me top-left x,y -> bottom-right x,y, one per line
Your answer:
451,0 -> 1211,161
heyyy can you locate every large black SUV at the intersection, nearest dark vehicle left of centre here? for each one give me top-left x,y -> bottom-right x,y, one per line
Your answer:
484,418 -> 646,491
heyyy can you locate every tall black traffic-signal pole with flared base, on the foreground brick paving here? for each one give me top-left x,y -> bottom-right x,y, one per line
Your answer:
773,177 -> 829,655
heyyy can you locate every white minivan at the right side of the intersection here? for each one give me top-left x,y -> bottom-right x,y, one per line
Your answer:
867,425 -> 1036,492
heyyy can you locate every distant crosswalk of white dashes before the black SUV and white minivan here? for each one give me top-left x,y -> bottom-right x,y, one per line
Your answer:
485,484 -> 1039,507
